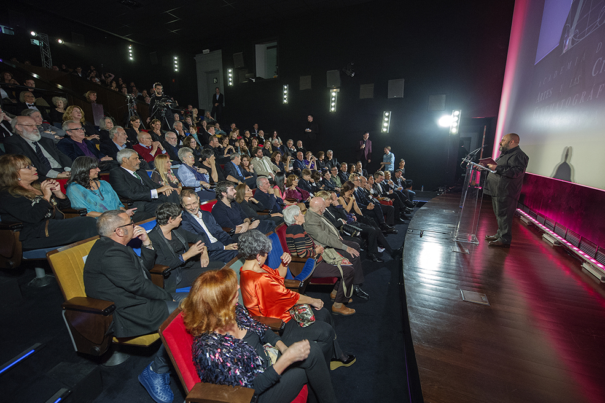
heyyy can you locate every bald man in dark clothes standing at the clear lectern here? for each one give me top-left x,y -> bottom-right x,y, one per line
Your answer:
484,133 -> 529,248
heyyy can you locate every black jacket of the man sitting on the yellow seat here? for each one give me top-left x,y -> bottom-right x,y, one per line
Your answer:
84,237 -> 172,337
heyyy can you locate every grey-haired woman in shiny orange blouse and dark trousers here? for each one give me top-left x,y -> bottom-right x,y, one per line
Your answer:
237,231 -> 355,369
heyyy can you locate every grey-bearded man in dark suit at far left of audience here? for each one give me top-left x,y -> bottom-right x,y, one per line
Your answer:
4,116 -> 71,179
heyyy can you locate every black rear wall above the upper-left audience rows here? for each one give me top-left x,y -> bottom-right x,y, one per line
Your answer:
0,2 -> 197,105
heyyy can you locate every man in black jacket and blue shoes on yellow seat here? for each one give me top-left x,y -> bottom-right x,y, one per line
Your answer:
84,210 -> 186,402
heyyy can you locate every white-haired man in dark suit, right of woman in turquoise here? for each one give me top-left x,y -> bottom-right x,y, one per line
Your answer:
109,148 -> 179,214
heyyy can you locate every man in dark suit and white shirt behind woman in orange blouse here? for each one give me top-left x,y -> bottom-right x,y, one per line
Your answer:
181,189 -> 237,264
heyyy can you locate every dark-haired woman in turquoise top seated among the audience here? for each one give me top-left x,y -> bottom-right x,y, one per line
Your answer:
65,157 -> 140,221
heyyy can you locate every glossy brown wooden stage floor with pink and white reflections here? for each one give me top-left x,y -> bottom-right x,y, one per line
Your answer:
403,194 -> 605,403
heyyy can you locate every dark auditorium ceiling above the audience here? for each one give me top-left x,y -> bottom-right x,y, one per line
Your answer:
24,0 -> 370,52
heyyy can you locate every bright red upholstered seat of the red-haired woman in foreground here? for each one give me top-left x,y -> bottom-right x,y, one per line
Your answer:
160,312 -> 308,403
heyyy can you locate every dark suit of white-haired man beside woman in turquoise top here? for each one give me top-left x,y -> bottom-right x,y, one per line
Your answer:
109,167 -> 179,212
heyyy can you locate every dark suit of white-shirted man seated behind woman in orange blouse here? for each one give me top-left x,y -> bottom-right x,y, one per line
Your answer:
181,211 -> 237,263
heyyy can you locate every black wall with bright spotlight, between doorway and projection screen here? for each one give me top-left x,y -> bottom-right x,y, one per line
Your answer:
222,1 -> 513,189
